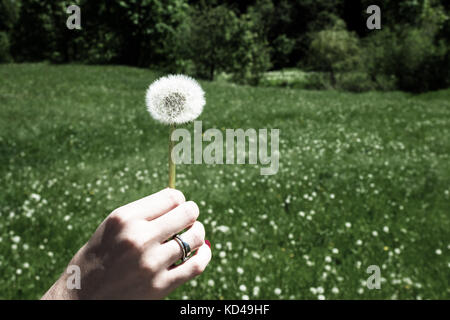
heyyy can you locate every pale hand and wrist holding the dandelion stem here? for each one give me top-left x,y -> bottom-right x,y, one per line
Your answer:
42,188 -> 211,299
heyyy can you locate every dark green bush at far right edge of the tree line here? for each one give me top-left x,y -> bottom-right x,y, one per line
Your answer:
365,28 -> 450,92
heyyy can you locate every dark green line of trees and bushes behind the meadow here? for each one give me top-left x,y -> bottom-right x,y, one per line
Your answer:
0,0 -> 450,92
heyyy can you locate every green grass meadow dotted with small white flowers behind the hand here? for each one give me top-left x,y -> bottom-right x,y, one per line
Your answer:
0,64 -> 450,299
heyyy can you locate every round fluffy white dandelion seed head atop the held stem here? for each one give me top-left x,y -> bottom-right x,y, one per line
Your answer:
145,75 -> 205,124
